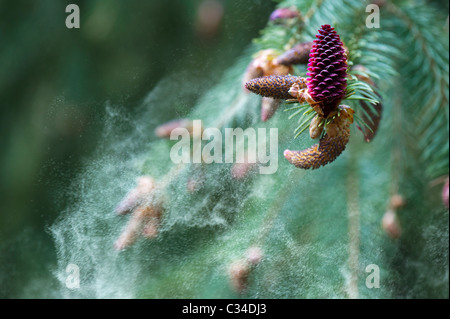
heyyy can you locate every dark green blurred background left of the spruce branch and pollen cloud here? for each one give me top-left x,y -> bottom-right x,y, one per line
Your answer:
0,0 -> 275,298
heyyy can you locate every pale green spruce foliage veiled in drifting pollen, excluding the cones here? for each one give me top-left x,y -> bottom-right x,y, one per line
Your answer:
52,0 -> 449,298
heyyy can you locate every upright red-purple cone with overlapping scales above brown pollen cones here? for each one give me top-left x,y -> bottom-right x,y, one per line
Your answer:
306,24 -> 347,117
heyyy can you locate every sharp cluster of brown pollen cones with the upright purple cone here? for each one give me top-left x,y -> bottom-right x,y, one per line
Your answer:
244,25 -> 354,169
